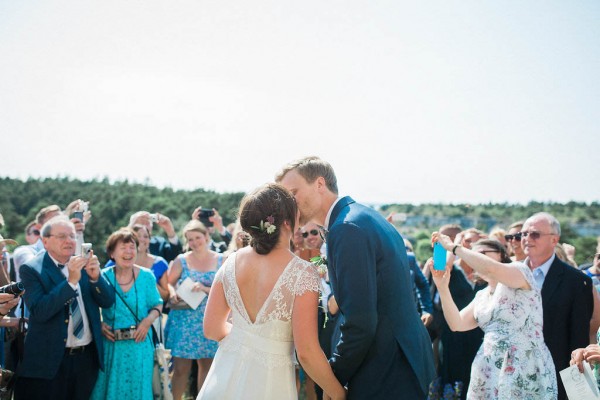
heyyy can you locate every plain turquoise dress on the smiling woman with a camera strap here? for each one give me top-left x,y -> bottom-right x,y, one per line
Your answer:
91,268 -> 162,400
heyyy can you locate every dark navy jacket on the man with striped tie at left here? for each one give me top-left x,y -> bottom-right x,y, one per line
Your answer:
19,251 -> 115,379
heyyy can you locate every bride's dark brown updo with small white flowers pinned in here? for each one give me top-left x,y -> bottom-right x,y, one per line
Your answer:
240,183 -> 298,255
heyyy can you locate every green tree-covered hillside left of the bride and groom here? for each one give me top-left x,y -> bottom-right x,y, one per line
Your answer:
0,178 -> 244,260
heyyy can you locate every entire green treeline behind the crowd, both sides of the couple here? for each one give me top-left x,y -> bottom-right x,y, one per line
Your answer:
0,178 -> 600,263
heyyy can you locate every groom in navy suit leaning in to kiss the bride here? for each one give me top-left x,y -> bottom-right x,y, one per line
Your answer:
275,157 -> 435,400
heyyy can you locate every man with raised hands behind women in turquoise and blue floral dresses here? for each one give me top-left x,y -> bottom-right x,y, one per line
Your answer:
128,211 -> 182,262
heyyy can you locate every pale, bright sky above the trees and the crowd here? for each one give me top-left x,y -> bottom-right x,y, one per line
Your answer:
0,0 -> 600,203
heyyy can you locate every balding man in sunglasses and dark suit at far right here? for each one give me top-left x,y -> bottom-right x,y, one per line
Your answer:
521,213 -> 594,400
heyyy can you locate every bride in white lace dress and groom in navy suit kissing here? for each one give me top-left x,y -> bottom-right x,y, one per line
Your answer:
198,157 -> 435,399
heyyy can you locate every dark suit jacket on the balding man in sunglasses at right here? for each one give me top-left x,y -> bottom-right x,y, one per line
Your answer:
542,257 -> 594,399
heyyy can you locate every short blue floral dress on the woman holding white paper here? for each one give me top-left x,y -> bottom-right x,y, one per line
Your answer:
165,254 -> 223,360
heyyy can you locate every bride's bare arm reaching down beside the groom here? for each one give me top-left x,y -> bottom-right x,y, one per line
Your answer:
292,291 -> 346,399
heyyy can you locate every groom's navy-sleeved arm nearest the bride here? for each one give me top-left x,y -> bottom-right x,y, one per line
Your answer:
327,223 -> 377,385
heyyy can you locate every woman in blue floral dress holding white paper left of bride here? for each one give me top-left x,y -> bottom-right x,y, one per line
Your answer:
165,220 -> 224,400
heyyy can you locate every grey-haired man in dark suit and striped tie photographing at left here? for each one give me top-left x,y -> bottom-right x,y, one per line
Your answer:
15,216 -> 115,400
